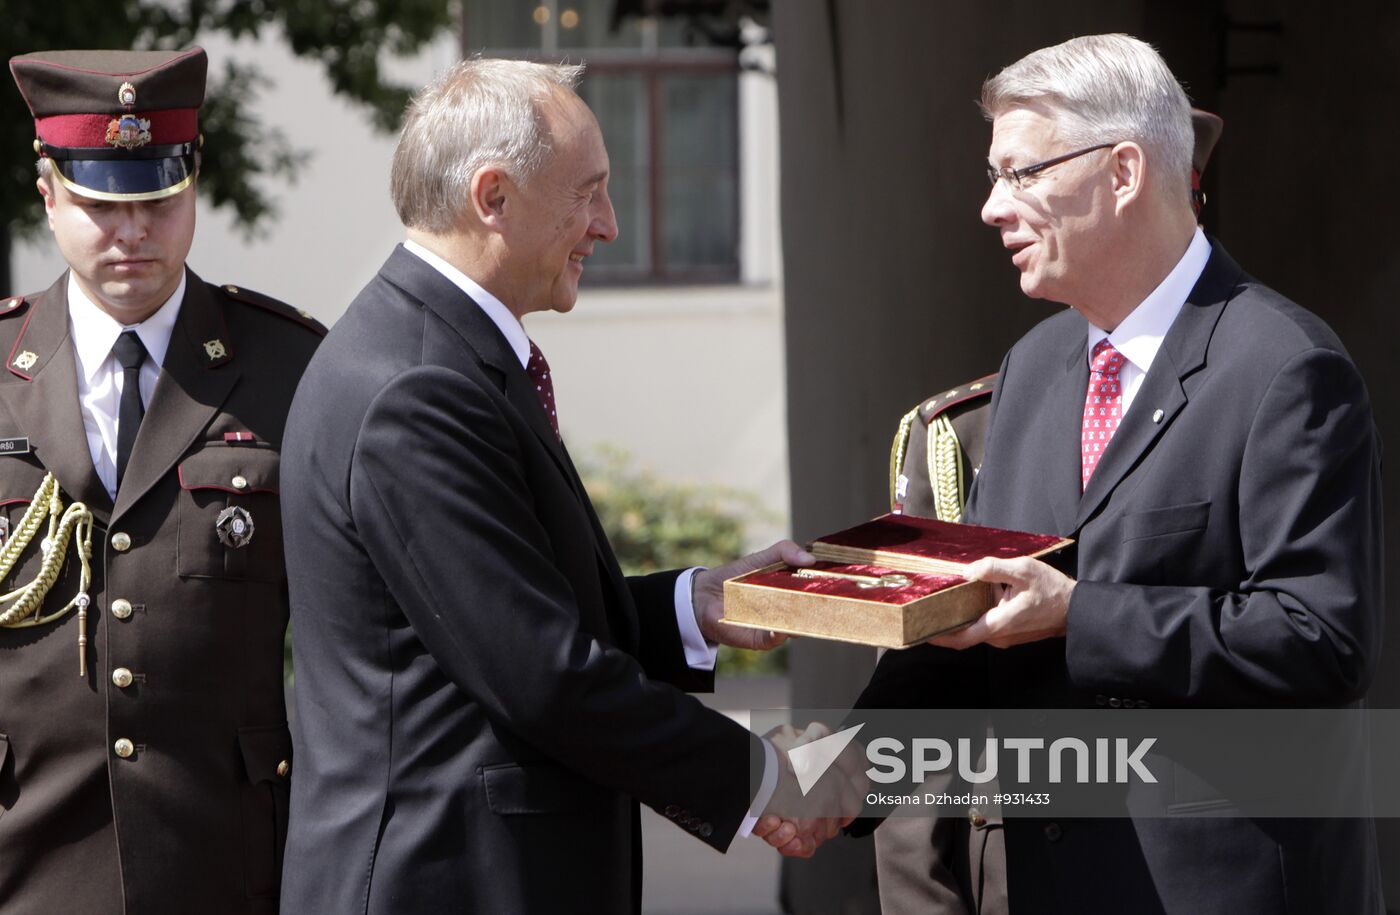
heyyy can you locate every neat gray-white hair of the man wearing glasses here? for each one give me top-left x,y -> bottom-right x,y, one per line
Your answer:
981,35 -> 1194,201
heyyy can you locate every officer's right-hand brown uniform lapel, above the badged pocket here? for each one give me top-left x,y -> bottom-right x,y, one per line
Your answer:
112,271 -> 239,520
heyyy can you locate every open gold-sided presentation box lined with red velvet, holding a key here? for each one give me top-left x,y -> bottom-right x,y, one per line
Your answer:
724,515 -> 1072,648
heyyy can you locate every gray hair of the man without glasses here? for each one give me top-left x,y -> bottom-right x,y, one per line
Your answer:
389,57 -> 584,232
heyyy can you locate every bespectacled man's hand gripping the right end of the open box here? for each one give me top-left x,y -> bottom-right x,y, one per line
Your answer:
928,557 -> 1075,648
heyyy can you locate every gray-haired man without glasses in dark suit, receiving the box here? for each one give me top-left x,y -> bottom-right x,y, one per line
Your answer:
273,60 -> 834,914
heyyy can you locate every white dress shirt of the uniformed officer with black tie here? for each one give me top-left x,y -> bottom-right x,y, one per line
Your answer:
69,273 -> 186,499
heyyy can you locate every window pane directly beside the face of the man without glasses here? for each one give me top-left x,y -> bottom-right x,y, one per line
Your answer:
580,73 -> 651,270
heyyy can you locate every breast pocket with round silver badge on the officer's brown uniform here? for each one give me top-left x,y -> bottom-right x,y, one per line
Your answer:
175,444 -> 286,582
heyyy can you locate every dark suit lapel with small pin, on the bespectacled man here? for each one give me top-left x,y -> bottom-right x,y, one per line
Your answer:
1071,246 -> 1240,533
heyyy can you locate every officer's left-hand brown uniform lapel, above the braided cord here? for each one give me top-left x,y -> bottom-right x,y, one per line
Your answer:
0,273 -> 112,523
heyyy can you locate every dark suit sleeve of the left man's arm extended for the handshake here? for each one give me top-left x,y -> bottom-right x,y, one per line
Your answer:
350,367 -> 763,849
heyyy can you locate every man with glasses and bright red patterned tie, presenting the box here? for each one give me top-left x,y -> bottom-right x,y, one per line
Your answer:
861,35 -> 1382,915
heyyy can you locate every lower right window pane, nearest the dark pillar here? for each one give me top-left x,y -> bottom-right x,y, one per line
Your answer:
662,74 -> 739,270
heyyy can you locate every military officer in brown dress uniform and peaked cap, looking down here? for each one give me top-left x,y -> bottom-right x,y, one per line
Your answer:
0,49 -> 325,915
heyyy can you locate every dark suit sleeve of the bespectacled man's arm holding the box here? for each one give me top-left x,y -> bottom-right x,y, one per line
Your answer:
1065,348 -> 1383,705
